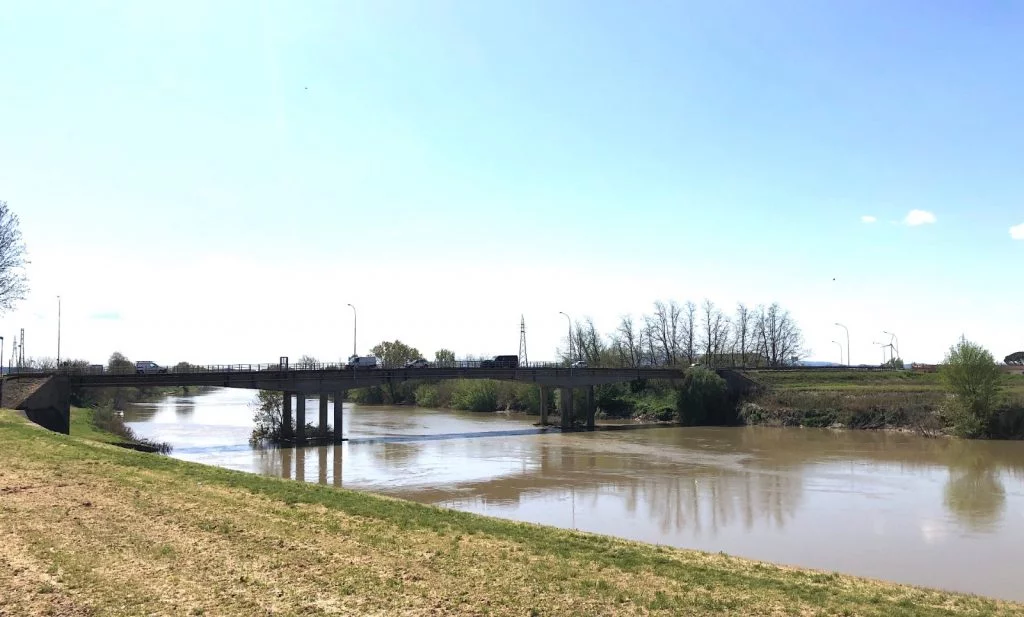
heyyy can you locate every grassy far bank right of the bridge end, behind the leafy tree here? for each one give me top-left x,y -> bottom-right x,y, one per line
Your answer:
740,370 -> 1024,438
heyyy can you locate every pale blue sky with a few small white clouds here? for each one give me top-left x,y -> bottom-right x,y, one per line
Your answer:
0,0 -> 1024,364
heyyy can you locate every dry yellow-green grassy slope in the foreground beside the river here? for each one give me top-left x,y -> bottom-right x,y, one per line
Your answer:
0,411 -> 1024,616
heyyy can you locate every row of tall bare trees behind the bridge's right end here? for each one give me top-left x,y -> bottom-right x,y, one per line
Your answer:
563,300 -> 806,367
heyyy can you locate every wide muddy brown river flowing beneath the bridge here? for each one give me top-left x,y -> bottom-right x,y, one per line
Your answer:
125,389 -> 1024,601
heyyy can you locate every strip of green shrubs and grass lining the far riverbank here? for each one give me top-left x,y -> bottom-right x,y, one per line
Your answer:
348,360 -> 1024,439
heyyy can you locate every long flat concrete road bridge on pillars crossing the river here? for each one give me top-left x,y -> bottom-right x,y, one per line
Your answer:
5,362 -> 683,443
